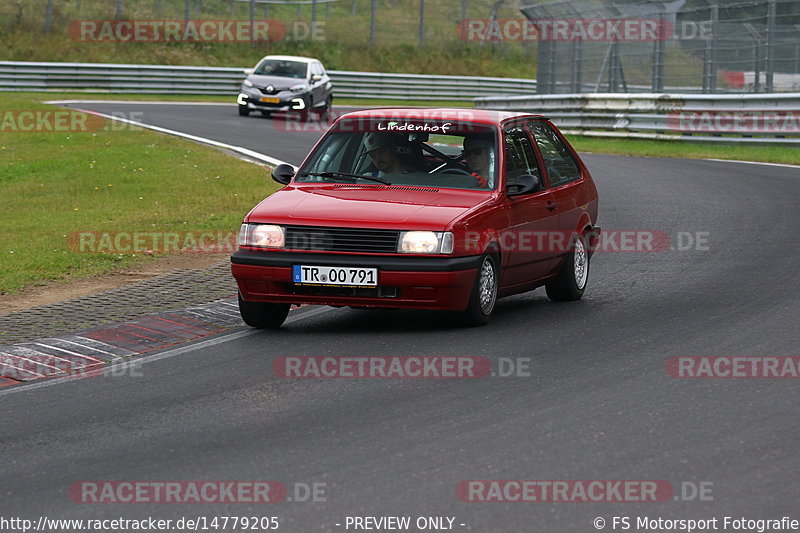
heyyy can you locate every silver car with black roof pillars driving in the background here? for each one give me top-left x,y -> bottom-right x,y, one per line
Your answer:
236,55 -> 333,121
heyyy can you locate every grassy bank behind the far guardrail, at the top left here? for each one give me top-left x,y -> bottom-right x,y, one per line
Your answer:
0,0 -> 536,78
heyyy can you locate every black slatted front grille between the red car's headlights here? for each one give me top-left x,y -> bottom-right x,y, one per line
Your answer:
286,222 -> 400,254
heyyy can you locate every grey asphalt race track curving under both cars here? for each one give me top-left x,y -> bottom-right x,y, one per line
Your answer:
0,104 -> 800,533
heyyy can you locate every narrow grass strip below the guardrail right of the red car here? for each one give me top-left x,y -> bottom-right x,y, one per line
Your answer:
567,135 -> 800,165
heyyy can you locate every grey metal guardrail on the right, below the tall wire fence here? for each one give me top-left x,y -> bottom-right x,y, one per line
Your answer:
475,93 -> 800,142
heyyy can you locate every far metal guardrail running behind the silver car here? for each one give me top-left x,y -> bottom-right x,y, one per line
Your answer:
0,61 -> 536,101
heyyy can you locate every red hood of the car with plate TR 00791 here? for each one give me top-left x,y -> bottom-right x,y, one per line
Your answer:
247,184 -> 492,230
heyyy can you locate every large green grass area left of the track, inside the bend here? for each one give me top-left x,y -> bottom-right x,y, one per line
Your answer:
0,93 -> 277,294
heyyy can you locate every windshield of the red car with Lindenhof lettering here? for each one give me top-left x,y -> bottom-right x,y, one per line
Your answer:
295,117 -> 497,190
